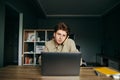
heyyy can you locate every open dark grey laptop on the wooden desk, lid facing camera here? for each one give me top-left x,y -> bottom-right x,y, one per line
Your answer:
41,52 -> 81,76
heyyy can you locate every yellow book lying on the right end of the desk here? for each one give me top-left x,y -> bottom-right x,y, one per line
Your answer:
93,67 -> 120,76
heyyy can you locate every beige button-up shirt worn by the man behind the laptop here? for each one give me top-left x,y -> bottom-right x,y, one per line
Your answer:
44,39 -> 79,52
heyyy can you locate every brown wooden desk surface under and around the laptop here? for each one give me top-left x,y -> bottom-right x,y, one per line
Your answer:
0,66 -> 114,80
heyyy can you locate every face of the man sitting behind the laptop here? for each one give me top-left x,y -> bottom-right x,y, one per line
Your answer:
54,30 -> 67,44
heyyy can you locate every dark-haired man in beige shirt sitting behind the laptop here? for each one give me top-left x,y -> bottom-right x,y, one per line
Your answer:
44,22 -> 79,52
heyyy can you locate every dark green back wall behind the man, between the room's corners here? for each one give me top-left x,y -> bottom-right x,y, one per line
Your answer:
38,17 -> 102,62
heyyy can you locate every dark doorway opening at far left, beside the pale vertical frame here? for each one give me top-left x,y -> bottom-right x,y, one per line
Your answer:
4,5 -> 19,66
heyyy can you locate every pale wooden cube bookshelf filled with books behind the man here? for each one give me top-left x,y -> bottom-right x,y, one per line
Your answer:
22,29 -> 53,65
